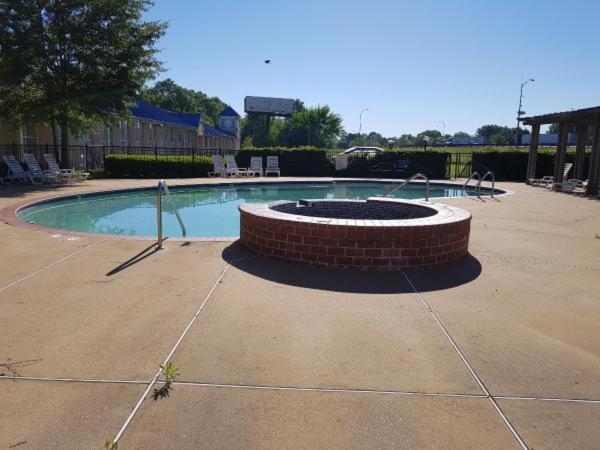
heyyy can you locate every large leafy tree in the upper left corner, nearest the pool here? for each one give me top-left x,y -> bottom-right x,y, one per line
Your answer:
0,0 -> 167,165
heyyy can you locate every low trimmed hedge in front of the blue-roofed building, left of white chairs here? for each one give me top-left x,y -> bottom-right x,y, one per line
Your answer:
104,155 -> 212,178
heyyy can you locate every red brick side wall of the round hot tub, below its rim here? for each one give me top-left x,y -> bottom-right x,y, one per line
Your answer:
240,209 -> 471,269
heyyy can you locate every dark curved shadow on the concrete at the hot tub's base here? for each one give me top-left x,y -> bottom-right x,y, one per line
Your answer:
222,242 -> 481,294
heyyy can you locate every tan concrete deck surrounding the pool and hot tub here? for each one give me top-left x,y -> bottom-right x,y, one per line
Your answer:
0,179 -> 600,449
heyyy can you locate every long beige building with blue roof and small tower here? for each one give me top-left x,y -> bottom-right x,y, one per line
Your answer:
0,100 -> 241,150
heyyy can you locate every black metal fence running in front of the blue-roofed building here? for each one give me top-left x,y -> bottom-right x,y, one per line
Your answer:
0,144 -> 238,170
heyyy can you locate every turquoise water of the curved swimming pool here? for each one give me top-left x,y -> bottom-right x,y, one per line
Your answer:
17,182 -> 494,237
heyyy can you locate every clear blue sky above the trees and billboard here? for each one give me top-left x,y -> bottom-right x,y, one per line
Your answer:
148,0 -> 600,136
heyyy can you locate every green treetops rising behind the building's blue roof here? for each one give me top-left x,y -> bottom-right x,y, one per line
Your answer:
139,78 -> 227,125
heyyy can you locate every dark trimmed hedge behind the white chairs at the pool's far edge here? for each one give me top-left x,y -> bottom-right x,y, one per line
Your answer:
235,147 -> 334,177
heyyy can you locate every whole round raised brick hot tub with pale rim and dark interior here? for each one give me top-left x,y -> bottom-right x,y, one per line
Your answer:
239,197 -> 471,269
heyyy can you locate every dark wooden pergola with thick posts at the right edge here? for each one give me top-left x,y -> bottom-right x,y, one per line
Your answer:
519,106 -> 600,195
